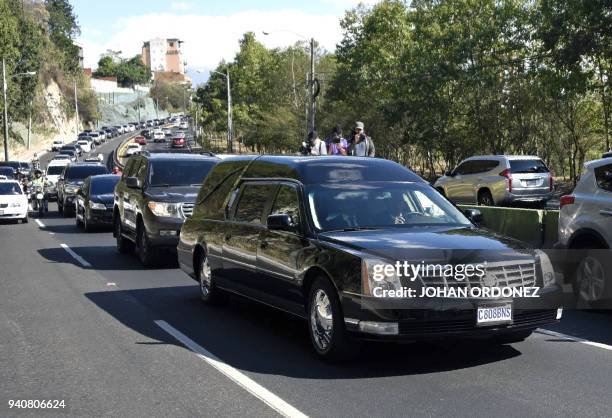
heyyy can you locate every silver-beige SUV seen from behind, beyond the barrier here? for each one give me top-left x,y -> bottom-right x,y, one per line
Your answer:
434,155 -> 553,206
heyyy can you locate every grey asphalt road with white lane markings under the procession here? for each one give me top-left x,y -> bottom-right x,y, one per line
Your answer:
0,136 -> 612,417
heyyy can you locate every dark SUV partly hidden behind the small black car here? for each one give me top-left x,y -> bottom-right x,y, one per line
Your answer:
57,163 -> 108,216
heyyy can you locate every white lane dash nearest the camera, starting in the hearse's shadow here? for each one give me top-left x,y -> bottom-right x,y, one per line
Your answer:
155,320 -> 307,417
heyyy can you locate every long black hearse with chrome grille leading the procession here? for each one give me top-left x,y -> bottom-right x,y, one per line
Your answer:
177,156 -> 561,359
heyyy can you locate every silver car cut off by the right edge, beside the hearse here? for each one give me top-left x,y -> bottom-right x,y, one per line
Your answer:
555,158 -> 612,306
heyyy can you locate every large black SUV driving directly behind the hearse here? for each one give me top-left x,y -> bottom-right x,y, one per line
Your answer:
113,153 -> 219,266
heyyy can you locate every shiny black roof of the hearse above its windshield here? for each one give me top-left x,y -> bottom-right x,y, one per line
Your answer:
232,155 -> 425,184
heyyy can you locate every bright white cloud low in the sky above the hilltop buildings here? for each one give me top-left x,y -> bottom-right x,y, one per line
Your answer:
79,9 -> 341,69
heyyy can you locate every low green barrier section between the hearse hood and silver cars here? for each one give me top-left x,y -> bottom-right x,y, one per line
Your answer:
459,205 -> 559,248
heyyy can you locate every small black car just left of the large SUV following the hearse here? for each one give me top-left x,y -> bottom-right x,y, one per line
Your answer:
75,174 -> 121,232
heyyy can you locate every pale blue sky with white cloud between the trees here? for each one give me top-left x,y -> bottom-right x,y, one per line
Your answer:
72,0 -> 375,85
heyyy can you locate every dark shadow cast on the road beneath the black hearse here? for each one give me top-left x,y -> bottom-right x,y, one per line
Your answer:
86,286 -> 521,379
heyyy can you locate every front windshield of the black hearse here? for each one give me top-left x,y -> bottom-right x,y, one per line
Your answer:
306,182 -> 472,231
